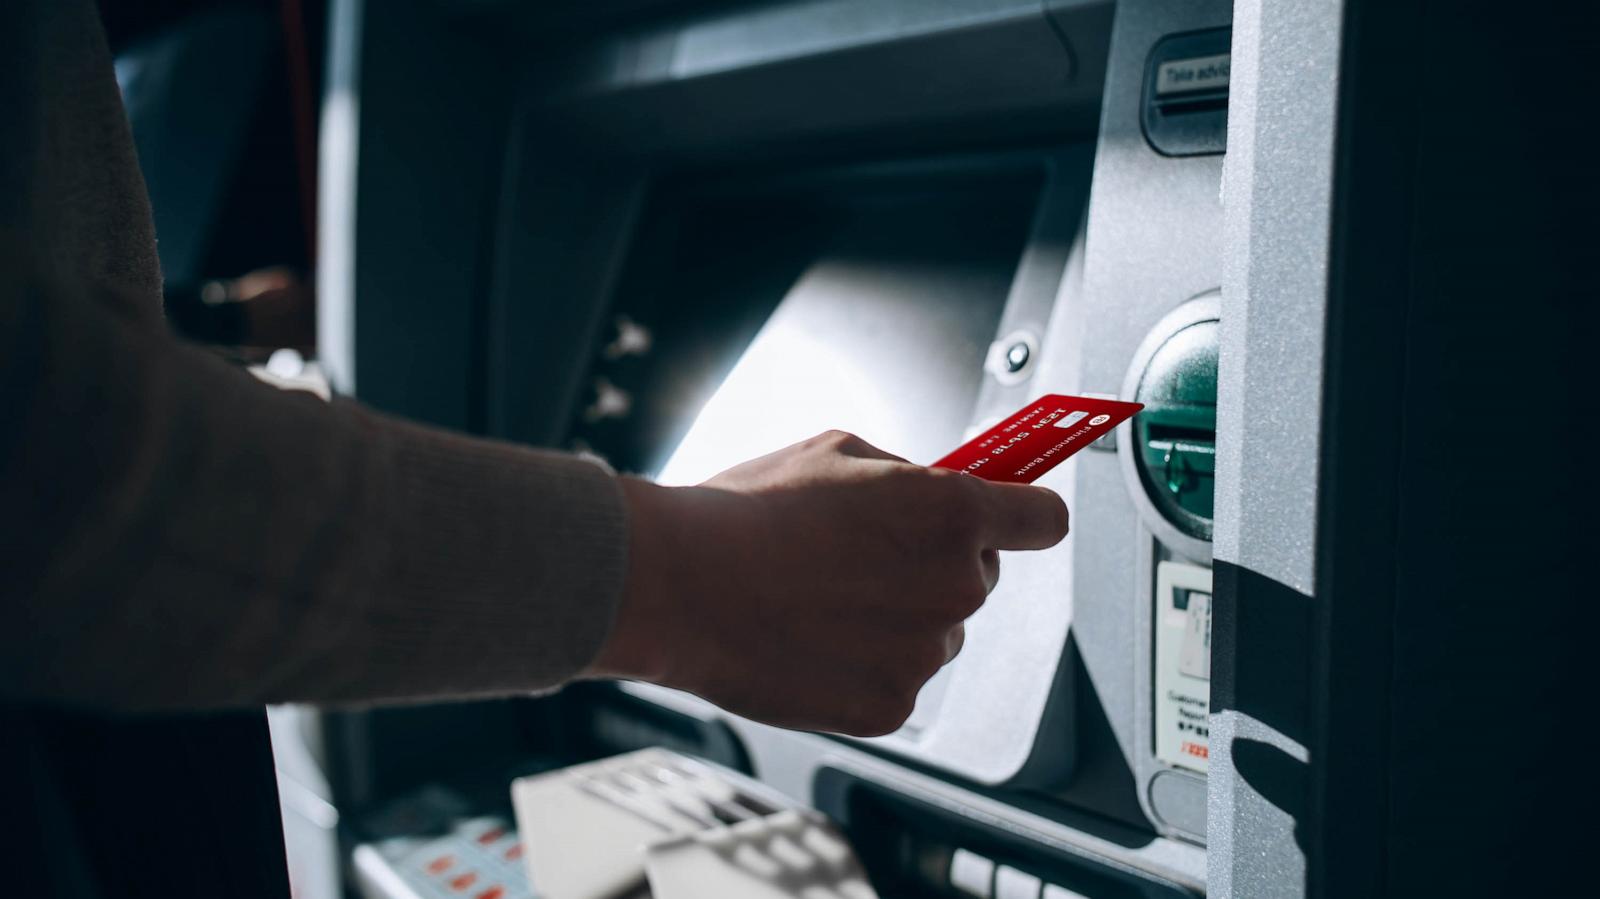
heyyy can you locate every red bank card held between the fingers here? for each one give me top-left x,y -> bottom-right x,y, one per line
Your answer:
933,394 -> 1144,483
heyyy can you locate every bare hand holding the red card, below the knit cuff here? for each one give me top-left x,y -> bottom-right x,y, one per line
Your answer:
589,432 -> 1067,736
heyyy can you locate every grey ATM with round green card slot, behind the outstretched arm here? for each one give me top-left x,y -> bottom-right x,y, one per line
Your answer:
278,0 -> 1587,899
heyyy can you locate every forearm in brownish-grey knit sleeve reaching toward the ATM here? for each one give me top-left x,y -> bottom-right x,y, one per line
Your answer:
0,262 -> 626,709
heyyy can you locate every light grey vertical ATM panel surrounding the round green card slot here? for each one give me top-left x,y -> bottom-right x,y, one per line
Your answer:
1072,2 -> 1232,840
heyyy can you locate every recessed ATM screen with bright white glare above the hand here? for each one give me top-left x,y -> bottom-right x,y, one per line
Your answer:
574,166 -> 1042,483
